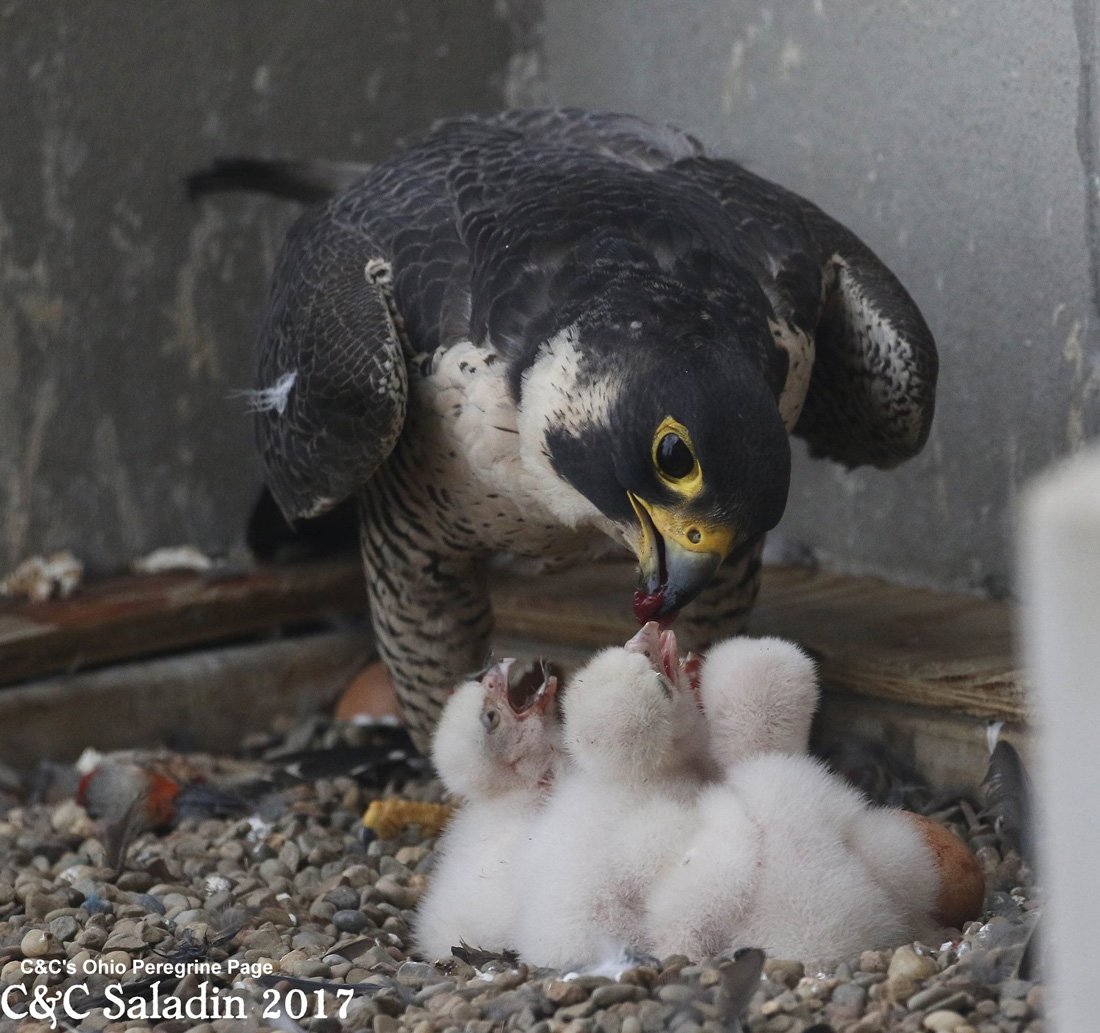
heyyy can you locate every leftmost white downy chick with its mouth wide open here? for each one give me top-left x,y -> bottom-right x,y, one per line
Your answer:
416,660 -> 562,957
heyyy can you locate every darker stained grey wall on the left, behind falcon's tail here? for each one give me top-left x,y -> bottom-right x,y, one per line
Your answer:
0,0 -> 521,572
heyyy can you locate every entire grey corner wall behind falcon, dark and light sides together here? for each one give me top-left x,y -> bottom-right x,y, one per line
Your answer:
0,0 -> 1100,592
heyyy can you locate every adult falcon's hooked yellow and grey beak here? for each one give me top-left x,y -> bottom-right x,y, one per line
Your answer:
627,492 -> 736,624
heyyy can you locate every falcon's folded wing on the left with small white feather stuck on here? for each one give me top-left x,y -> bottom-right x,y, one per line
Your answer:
252,205 -> 408,519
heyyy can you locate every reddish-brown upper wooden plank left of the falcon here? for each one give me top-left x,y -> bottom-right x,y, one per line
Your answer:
0,560 -> 366,684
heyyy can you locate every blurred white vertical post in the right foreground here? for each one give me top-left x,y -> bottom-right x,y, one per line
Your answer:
1020,448 -> 1100,1033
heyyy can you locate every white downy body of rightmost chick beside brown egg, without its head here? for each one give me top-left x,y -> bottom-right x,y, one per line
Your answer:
649,752 -> 938,963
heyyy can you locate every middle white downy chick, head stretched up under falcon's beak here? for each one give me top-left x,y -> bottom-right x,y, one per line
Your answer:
516,647 -> 700,967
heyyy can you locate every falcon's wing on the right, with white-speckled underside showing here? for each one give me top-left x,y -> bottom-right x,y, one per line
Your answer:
672,157 -> 938,468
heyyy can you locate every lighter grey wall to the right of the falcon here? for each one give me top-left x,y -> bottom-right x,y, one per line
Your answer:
534,0 -> 1100,592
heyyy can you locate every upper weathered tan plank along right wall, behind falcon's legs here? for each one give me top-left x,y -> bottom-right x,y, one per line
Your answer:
494,564 -> 1027,722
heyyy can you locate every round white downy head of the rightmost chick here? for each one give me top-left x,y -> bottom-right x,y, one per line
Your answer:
700,638 -> 817,769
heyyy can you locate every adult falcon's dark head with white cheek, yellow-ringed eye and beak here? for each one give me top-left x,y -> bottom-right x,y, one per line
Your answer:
519,299 -> 791,622
